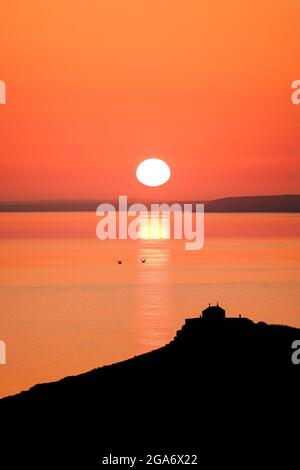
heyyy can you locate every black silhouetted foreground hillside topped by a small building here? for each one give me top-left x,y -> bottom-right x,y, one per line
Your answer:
0,307 -> 300,469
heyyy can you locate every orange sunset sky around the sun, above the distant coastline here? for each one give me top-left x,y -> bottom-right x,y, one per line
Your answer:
0,0 -> 300,200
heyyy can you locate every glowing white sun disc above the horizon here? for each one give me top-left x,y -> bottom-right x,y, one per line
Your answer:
136,158 -> 171,186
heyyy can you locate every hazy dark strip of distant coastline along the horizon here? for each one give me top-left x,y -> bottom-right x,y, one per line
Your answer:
0,194 -> 300,213
